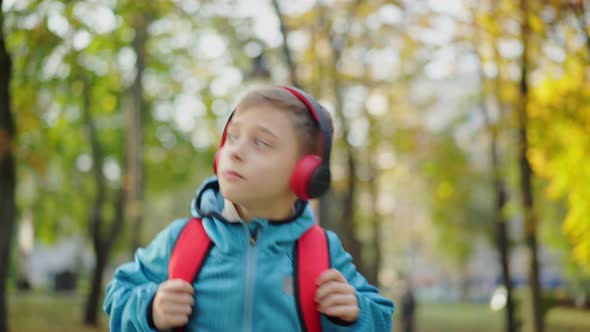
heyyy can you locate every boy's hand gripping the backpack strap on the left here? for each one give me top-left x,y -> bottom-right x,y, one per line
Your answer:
152,279 -> 194,330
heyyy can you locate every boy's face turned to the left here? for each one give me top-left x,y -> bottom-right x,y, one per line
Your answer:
218,105 -> 298,206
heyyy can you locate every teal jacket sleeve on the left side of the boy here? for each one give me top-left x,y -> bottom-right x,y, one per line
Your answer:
103,219 -> 187,332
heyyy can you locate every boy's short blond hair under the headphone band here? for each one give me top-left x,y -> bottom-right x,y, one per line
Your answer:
237,86 -> 334,156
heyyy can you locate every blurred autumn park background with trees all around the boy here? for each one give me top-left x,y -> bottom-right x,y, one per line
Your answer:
0,0 -> 590,332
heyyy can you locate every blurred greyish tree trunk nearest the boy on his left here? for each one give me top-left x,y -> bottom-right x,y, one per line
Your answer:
125,14 -> 147,257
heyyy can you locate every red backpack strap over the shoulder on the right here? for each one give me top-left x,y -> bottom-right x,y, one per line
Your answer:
293,224 -> 330,332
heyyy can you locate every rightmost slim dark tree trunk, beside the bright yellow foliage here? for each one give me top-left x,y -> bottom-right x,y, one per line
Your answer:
518,0 -> 544,332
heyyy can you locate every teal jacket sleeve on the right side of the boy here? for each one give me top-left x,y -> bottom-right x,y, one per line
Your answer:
321,231 -> 394,332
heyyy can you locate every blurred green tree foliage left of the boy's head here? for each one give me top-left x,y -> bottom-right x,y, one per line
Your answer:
5,0 -> 252,252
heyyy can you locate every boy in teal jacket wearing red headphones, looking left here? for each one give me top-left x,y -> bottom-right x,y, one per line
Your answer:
104,86 -> 393,332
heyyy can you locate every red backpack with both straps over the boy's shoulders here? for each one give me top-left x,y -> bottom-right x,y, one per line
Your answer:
168,218 -> 330,332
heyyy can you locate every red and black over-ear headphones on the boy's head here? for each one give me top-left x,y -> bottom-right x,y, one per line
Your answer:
213,86 -> 332,200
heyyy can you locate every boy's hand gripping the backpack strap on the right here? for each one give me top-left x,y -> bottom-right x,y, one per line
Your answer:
315,269 -> 359,322
